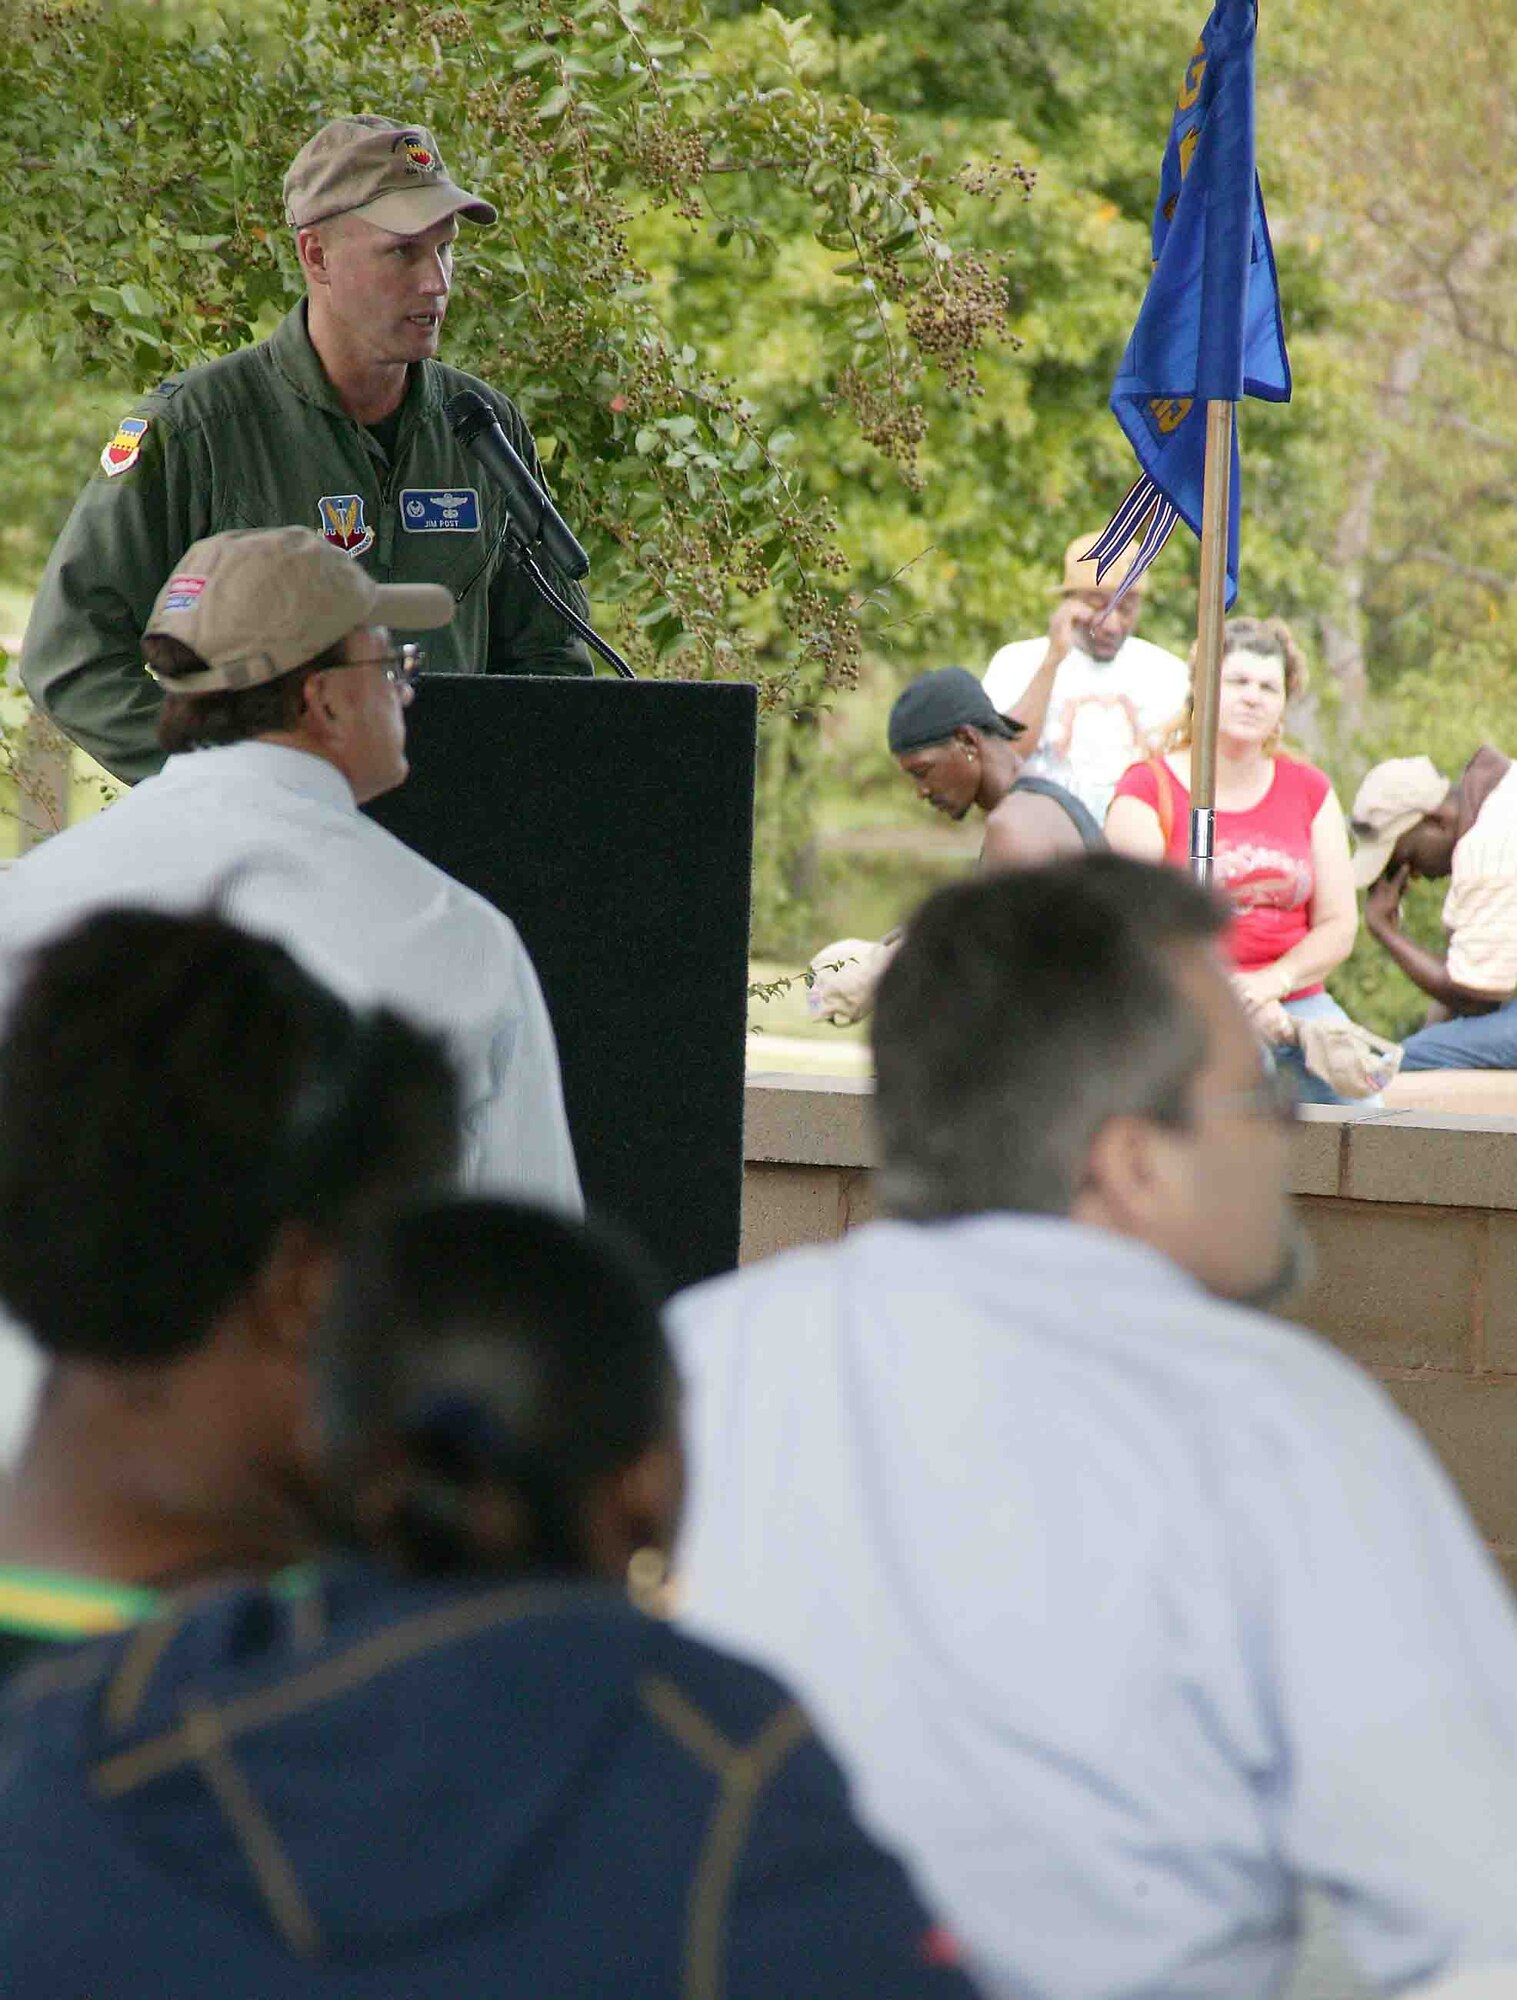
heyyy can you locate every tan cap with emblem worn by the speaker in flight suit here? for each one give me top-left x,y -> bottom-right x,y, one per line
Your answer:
284,112 -> 496,236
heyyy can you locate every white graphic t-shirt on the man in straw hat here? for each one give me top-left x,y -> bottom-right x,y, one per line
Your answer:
985,636 -> 1191,820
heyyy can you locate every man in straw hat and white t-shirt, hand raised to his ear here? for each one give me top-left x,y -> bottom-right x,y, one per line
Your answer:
985,534 -> 1189,820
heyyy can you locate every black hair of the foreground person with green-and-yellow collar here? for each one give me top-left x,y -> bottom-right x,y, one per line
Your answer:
0,910 -> 458,1366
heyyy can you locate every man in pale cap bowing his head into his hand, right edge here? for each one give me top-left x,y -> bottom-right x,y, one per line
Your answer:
1349,744 -> 1517,1070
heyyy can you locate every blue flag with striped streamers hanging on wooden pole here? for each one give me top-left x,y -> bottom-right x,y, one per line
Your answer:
1089,0 -> 1291,608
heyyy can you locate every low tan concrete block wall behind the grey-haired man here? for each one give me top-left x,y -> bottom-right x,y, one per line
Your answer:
742,1076 -> 1517,1586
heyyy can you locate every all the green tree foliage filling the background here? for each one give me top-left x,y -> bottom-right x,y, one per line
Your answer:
0,0 -> 1517,996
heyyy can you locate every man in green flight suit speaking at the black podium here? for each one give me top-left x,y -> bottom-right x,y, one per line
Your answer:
22,116 -> 590,782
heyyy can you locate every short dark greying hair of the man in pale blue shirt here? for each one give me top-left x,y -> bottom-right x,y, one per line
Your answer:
875,854 -> 1225,1218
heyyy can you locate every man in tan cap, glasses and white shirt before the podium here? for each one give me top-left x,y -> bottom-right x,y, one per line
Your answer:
0,528 -> 582,1214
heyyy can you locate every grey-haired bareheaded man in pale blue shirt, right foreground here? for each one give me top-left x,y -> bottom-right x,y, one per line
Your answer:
672,856 -> 1517,2000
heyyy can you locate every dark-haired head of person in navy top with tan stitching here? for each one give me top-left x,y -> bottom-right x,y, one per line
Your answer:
314,1200 -> 680,1576
